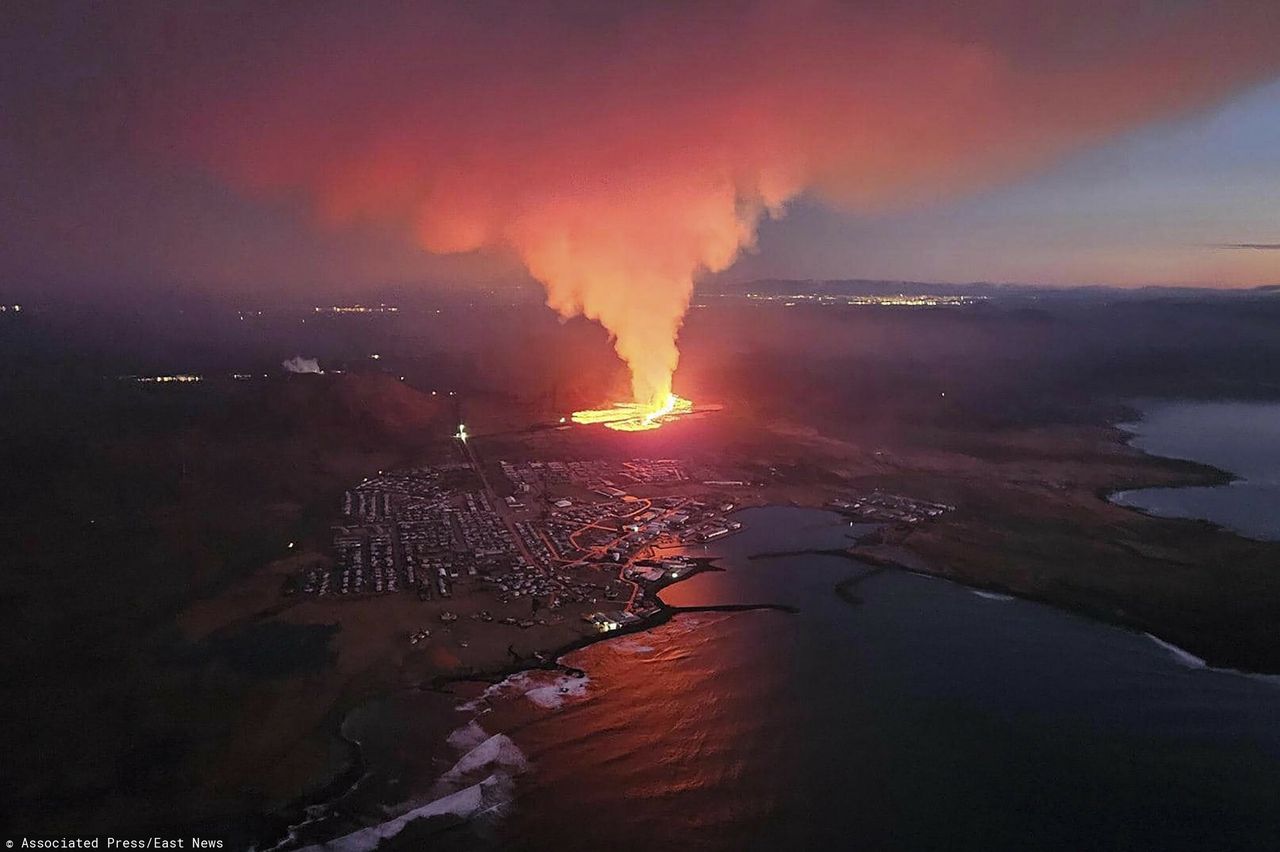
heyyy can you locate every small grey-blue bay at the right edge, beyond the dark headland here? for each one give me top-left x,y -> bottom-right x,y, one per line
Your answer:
1112,402 -> 1280,540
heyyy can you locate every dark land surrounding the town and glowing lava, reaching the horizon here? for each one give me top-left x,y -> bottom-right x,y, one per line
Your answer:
0,281 -> 1280,833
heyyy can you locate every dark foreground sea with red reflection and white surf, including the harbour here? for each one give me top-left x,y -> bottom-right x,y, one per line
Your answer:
304,507 -> 1280,852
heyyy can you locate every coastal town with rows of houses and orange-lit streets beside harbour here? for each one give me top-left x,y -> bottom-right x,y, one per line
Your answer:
287,450 -> 742,637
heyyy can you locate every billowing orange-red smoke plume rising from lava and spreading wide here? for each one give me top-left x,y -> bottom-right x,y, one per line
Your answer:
174,0 -> 1280,422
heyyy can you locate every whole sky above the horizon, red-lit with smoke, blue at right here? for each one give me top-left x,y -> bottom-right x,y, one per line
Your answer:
0,0 -> 1280,301
